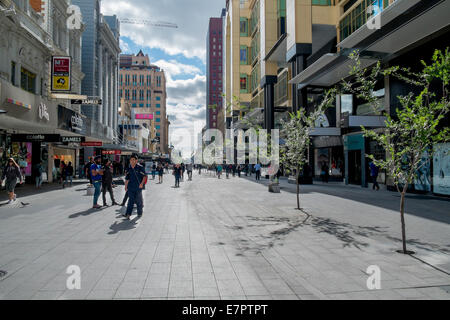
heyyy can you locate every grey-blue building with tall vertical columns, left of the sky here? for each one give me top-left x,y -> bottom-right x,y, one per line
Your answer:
72,0 -> 120,141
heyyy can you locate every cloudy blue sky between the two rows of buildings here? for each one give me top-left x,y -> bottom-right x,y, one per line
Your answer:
102,0 -> 225,157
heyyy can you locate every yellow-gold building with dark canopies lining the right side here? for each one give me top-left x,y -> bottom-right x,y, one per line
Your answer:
223,0 -> 450,193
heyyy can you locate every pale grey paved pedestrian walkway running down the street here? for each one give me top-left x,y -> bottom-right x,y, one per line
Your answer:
0,172 -> 450,299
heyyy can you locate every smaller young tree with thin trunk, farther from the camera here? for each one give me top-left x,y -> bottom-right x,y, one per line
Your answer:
280,89 -> 336,210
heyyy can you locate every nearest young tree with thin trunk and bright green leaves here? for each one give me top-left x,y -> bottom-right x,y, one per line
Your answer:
343,49 -> 450,254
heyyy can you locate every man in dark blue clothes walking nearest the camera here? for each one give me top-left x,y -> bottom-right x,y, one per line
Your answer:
124,155 -> 148,220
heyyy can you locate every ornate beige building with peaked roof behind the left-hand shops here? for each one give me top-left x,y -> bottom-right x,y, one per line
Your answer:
119,50 -> 169,154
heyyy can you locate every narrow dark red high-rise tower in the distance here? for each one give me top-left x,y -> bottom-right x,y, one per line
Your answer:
206,9 -> 225,132
